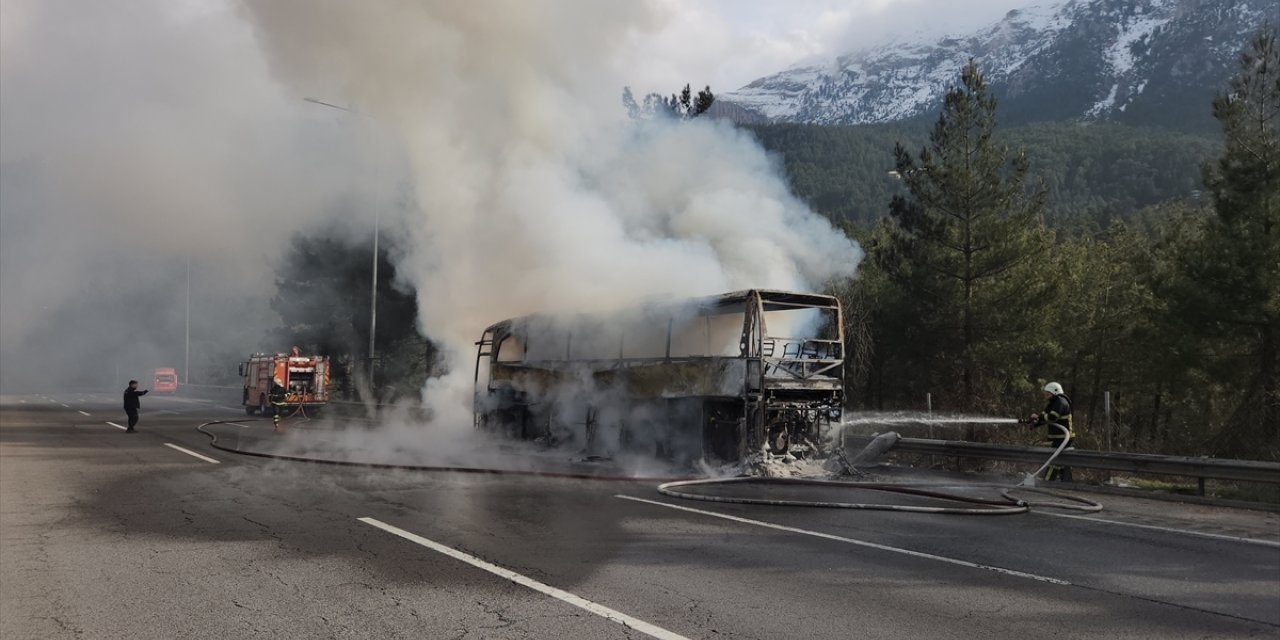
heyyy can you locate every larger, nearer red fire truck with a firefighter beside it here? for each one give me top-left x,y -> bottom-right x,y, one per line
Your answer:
239,347 -> 329,416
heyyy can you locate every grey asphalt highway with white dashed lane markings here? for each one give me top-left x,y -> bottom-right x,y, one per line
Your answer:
0,394 -> 1280,640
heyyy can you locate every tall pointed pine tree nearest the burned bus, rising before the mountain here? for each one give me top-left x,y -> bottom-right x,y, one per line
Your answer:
874,60 -> 1052,408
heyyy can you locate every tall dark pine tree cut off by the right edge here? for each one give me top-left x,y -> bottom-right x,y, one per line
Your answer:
1170,28 -> 1280,457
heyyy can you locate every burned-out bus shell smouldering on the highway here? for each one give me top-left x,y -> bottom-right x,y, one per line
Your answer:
475,289 -> 844,463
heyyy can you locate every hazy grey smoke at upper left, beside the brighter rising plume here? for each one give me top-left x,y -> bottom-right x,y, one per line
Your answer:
0,0 -> 378,392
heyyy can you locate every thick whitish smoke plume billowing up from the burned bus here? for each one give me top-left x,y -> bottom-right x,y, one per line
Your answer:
246,0 -> 861,421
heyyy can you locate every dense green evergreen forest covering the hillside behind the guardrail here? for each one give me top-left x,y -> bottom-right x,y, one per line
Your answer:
814,29 -> 1280,460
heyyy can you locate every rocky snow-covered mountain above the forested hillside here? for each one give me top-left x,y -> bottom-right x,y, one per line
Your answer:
717,0 -> 1280,127
